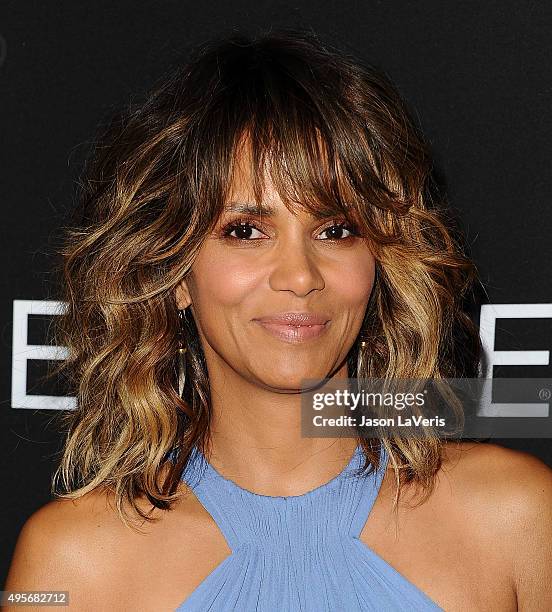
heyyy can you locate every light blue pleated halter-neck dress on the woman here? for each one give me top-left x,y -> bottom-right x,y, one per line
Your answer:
177,446 -> 442,612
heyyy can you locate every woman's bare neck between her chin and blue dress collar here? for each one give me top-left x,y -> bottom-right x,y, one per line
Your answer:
198,354 -> 358,496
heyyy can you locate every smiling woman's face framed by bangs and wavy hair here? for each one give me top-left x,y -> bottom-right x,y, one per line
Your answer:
176,150 -> 375,392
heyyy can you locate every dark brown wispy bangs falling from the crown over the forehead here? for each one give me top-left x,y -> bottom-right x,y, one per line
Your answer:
179,34 -> 417,234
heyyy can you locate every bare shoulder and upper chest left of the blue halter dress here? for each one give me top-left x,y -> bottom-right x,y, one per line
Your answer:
5,486 -> 216,612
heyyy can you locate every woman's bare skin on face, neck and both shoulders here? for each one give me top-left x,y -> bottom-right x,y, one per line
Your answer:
4,146 -> 552,612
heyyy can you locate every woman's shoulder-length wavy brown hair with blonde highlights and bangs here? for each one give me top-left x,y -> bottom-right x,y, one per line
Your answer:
52,30 -> 481,523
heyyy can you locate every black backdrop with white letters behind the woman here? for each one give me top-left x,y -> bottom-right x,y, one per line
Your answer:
0,0 -> 552,582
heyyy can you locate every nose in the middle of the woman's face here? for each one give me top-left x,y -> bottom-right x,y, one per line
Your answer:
269,238 -> 325,297
